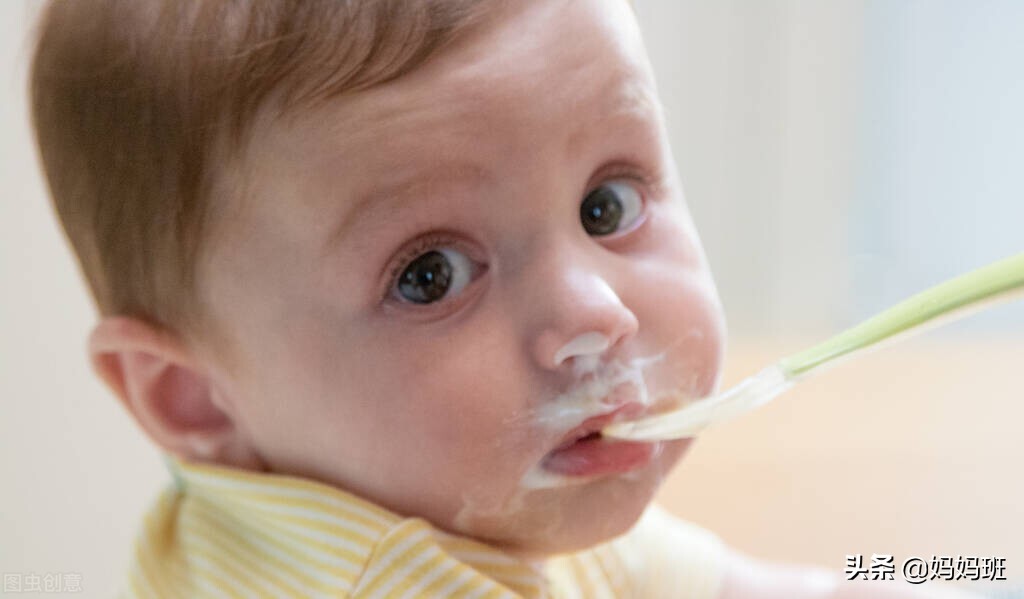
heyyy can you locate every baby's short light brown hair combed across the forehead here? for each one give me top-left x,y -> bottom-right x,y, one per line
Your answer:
31,0 -> 481,330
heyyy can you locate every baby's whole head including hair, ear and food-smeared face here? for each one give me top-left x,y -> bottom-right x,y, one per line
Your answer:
33,0 -> 724,555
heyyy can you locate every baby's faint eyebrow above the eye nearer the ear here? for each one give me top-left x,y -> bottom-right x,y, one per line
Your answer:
324,162 -> 494,252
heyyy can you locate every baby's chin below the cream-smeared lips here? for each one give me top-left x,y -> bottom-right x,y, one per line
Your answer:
455,439 -> 690,559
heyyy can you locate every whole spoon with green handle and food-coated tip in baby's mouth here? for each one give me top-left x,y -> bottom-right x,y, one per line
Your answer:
601,253 -> 1024,440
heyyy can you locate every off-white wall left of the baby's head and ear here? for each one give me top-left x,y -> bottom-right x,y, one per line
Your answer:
0,2 -> 165,597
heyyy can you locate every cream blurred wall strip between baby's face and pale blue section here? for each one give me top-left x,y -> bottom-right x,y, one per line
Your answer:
637,0 -> 863,335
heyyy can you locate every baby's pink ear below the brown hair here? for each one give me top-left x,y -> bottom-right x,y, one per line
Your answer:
89,316 -> 261,469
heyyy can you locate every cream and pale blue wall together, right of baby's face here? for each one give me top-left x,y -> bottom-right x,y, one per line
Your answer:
637,0 -> 1024,337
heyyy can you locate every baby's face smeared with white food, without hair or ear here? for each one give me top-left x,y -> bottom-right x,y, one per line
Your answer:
201,0 -> 723,554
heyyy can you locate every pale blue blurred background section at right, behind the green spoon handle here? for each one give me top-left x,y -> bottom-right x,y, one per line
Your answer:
849,0 -> 1024,331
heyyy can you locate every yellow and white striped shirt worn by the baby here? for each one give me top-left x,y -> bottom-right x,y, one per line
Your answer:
122,459 -> 724,599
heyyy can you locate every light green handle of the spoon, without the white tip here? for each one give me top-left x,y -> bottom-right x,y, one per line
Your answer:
777,253 -> 1024,379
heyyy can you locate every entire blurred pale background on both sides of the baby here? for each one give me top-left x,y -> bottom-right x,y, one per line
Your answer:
0,0 -> 1024,597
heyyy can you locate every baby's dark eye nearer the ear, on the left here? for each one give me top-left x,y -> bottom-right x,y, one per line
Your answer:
395,248 -> 473,304
